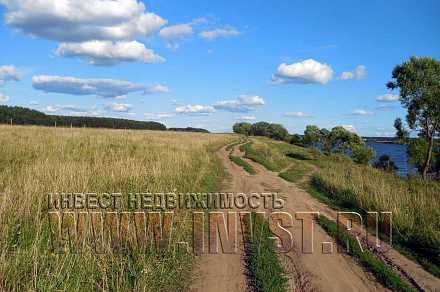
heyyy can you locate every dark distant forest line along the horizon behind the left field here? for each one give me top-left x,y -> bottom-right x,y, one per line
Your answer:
0,106 -> 209,133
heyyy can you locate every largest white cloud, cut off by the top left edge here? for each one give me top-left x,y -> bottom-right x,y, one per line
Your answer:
2,0 -> 166,42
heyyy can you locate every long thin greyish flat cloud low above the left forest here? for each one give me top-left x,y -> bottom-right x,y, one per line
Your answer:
32,75 -> 146,98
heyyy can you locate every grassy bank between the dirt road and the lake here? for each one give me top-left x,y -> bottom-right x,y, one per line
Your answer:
243,138 -> 440,276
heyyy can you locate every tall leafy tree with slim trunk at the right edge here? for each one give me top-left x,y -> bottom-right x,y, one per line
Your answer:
387,57 -> 440,178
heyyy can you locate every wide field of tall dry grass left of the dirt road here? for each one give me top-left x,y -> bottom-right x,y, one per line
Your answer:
0,126 -> 233,291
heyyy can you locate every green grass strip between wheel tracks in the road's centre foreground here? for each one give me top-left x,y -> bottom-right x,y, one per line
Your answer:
247,214 -> 288,292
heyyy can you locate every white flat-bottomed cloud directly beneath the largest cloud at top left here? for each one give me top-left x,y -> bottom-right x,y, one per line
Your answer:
55,40 -> 165,65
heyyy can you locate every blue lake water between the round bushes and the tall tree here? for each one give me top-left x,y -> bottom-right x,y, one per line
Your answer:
367,142 -> 416,177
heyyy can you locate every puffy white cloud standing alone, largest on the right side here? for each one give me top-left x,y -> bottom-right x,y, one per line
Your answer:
272,59 -> 333,84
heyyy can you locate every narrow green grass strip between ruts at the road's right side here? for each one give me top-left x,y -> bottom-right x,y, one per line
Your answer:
318,216 -> 416,291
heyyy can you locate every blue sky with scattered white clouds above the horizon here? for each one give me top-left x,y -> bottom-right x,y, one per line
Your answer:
0,0 -> 440,136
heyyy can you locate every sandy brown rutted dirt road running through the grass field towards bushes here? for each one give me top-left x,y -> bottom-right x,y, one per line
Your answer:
191,147 -> 440,291
